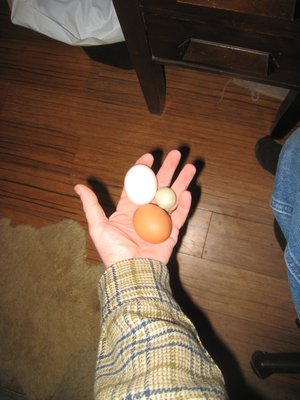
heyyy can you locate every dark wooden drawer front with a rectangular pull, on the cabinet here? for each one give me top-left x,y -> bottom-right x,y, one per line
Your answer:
144,10 -> 300,87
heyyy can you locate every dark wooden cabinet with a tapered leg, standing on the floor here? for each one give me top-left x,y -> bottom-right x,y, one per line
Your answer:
113,0 -> 300,136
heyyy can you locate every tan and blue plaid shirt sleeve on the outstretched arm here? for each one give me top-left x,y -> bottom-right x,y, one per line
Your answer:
95,259 -> 227,400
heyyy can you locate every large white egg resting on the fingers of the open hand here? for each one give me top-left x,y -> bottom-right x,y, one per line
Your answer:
124,164 -> 157,205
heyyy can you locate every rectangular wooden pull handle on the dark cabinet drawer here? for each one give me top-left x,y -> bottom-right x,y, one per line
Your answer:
178,39 -> 279,77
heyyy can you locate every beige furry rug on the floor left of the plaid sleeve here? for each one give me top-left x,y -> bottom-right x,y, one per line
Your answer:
0,219 -> 104,400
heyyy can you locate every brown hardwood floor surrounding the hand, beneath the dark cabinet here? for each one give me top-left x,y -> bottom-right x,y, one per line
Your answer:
0,0 -> 300,400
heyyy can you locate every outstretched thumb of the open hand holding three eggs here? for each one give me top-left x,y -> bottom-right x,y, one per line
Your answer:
74,185 -> 107,239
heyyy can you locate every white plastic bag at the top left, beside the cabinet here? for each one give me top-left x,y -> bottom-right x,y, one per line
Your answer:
7,0 -> 124,46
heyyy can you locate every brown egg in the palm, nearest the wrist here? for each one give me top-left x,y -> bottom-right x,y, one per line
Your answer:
133,204 -> 172,243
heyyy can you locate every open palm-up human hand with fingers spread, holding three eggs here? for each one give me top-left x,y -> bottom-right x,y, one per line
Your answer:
74,150 -> 196,267
